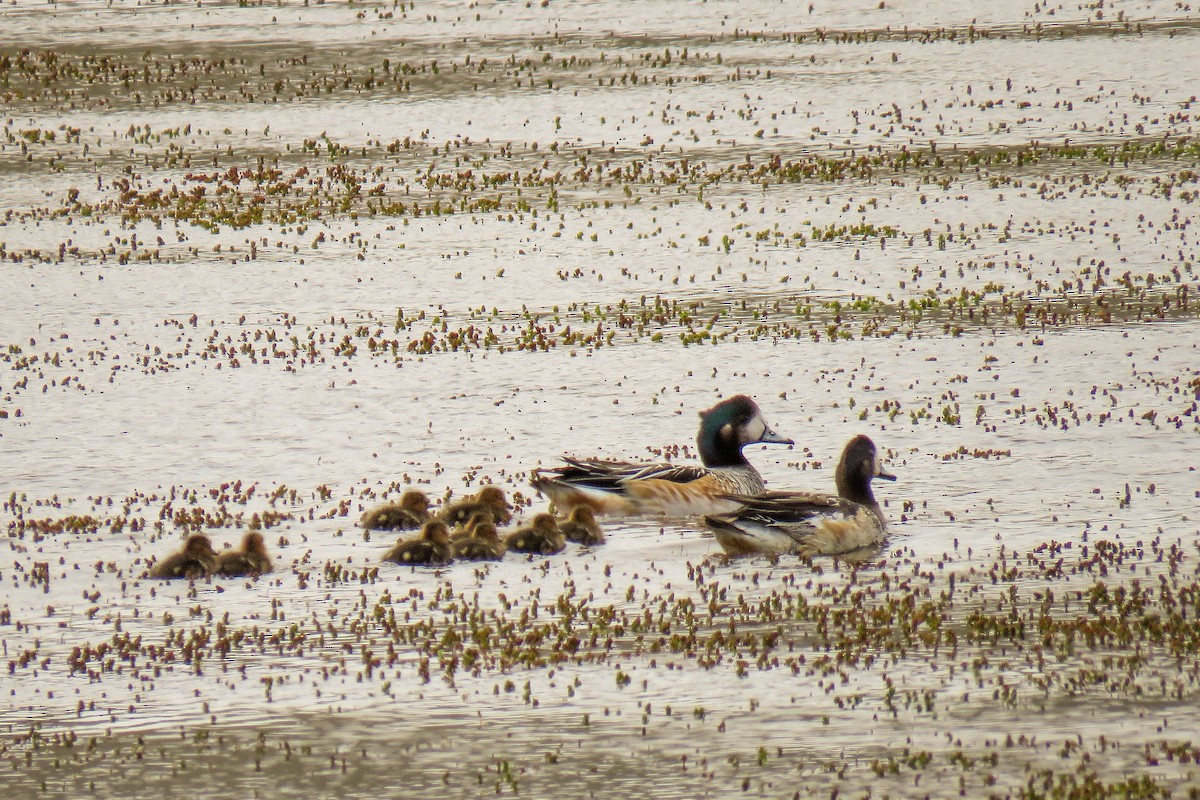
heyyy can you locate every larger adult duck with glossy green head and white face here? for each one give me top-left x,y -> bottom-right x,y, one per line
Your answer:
532,395 -> 794,516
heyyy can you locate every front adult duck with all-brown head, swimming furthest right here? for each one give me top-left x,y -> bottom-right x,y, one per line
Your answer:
704,435 -> 896,557
